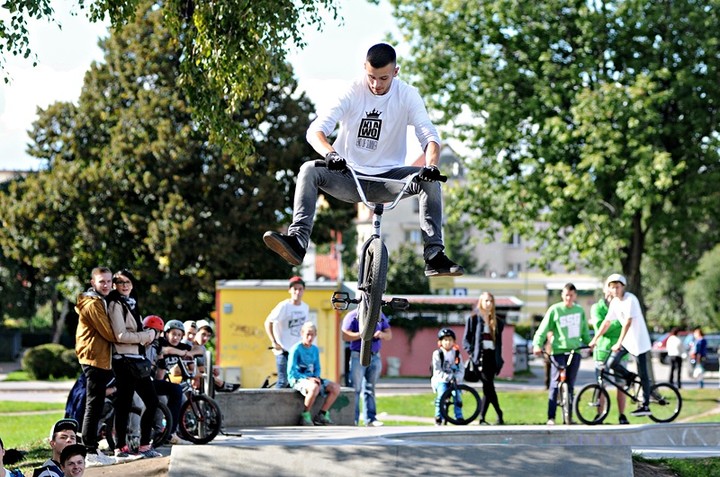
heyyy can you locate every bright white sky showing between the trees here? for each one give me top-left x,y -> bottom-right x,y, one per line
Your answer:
0,0 -> 404,170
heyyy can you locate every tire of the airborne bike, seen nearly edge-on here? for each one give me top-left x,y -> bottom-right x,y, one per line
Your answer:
358,238 -> 388,366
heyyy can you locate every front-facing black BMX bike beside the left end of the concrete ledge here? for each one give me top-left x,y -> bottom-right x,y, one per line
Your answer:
178,358 -> 222,444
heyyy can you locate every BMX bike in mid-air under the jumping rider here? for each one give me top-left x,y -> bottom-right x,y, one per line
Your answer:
330,161 -> 447,366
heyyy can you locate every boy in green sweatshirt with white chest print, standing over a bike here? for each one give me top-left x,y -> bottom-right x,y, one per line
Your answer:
533,283 -> 590,426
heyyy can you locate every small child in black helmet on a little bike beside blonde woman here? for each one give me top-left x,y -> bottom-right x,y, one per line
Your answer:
430,328 -> 464,426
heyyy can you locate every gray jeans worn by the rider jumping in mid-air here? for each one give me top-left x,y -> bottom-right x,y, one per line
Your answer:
288,161 -> 445,260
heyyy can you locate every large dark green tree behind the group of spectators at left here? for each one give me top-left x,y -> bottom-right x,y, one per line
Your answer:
0,2 -> 332,319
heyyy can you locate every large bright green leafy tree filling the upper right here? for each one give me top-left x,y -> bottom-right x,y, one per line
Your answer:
391,0 -> 720,308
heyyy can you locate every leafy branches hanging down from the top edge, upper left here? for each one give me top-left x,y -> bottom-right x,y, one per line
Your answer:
0,0 -> 337,165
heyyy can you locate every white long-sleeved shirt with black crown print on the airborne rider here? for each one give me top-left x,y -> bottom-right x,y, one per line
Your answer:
307,77 -> 440,174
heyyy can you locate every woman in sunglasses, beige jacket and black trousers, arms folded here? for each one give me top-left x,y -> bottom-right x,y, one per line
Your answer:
106,270 -> 162,458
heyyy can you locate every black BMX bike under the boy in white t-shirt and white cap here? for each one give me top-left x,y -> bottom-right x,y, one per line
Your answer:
575,358 -> 682,425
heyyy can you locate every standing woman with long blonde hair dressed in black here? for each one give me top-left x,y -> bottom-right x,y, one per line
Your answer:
463,292 -> 505,425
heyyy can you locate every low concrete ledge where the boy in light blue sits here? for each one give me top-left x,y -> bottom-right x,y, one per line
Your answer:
215,388 -> 355,428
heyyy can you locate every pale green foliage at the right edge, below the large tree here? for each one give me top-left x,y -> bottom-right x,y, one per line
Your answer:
685,245 -> 720,329
